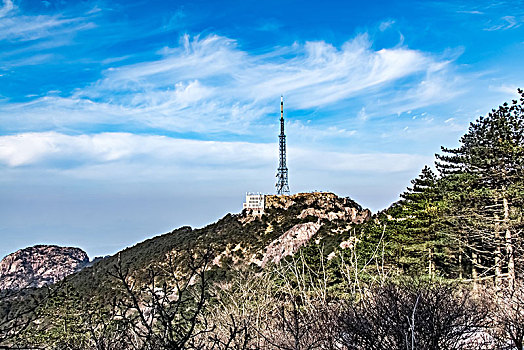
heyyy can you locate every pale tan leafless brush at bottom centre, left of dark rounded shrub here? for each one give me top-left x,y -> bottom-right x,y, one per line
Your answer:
207,256 -> 338,350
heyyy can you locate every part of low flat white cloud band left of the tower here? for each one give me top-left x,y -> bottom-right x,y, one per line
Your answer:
0,132 -> 273,168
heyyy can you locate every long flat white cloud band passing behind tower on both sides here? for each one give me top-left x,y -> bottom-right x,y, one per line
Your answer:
0,132 -> 427,177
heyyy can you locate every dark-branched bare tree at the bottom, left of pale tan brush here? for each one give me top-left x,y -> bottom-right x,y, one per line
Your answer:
111,252 -> 215,349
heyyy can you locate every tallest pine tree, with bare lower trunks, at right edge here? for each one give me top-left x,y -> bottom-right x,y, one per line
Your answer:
436,89 -> 524,284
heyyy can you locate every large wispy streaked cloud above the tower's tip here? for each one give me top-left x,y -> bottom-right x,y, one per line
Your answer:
0,35 -> 464,134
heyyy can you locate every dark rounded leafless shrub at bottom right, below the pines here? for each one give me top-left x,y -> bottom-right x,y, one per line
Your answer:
340,282 -> 488,350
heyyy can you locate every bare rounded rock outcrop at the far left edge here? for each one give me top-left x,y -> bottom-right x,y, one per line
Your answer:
0,245 -> 89,290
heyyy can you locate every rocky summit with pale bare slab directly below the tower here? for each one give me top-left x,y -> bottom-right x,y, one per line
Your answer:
217,192 -> 371,267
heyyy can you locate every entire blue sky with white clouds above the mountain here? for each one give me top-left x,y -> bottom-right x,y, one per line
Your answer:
0,0 -> 524,258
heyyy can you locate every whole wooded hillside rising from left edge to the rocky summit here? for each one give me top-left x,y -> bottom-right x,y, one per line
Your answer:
0,192 -> 371,348
